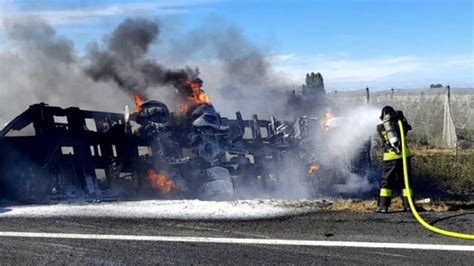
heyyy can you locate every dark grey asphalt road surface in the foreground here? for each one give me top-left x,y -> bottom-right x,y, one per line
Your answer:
0,211 -> 474,265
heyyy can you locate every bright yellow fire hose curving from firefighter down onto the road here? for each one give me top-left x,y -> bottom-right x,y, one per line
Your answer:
398,121 -> 474,240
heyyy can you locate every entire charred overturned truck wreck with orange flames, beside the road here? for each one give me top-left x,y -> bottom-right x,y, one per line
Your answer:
0,74 -> 371,202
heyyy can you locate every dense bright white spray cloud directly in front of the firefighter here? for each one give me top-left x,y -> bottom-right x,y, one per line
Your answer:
314,106 -> 380,195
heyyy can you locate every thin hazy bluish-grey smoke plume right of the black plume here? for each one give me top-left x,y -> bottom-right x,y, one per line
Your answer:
156,20 -> 291,119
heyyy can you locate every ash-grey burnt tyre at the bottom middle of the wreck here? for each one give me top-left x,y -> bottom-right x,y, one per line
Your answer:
198,167 -> 234,200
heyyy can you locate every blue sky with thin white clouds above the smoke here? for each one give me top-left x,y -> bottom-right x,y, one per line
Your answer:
0,0 -> 474,89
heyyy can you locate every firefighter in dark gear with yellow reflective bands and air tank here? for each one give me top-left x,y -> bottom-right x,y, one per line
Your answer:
375,106 -> 413,213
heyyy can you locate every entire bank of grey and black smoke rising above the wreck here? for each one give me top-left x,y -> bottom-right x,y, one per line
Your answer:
0,17 -> 288,124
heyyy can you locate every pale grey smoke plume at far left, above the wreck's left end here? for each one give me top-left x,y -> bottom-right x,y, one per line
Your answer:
0,17 -> 129,125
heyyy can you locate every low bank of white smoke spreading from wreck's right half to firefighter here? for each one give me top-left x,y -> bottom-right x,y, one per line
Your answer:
233,106 -> 380,199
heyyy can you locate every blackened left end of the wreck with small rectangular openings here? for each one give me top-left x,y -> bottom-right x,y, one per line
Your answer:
0,103 -> 150,200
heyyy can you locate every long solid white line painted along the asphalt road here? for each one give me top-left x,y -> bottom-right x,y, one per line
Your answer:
0,232 -> 474,251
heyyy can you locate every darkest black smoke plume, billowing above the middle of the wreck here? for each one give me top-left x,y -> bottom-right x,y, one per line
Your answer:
84,19 -> 199,94
